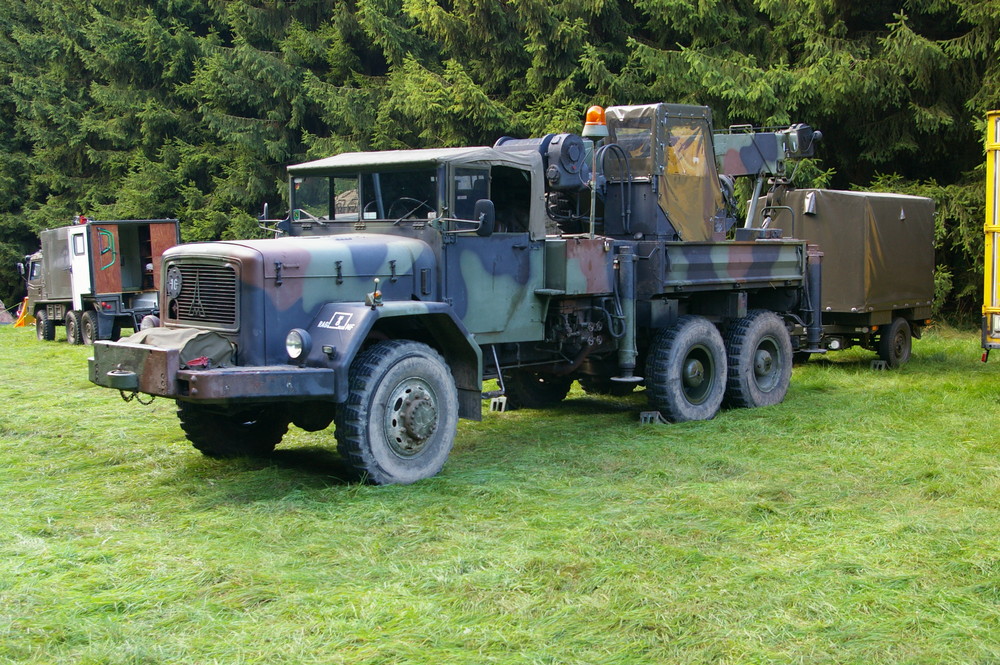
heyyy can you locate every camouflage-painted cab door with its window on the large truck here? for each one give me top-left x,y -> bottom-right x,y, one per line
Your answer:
445,166 -> 545,344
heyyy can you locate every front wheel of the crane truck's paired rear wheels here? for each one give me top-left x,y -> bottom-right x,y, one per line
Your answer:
646,315 -> 726,423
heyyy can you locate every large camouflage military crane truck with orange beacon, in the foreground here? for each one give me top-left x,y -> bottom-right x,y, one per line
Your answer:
90,104 -> 928,484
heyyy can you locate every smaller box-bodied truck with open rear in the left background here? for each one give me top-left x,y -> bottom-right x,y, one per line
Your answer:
19,217 -> 180,344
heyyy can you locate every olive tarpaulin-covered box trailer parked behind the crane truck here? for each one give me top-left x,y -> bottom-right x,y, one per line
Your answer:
758,187 -> 934,367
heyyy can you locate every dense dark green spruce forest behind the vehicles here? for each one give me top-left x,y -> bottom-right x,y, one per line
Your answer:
0,0 -> 1000,320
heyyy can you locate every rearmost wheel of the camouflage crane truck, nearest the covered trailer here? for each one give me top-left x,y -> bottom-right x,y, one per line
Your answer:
725,310 -> 792,408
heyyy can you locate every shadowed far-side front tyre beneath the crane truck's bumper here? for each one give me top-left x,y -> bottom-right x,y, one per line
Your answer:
177,402 -> 288,459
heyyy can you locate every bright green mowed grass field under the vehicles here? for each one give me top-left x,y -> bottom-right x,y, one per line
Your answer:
0,326 -> 1000,664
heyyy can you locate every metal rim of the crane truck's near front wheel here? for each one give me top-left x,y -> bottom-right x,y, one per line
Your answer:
384,377 -> 438,457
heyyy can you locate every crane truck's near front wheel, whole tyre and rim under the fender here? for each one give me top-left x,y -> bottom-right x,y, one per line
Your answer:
334,340 -> 458,485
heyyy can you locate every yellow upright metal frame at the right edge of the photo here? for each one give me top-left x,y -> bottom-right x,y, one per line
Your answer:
983,111 -> 1000,361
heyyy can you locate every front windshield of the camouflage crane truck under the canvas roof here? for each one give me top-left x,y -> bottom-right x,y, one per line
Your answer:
292,168 -> 439,222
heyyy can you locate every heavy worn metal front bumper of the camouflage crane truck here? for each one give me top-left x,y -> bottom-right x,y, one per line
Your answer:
89,341 -> 336,402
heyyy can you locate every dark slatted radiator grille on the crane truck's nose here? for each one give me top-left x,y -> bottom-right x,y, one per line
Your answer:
167,263 -> 239,328
